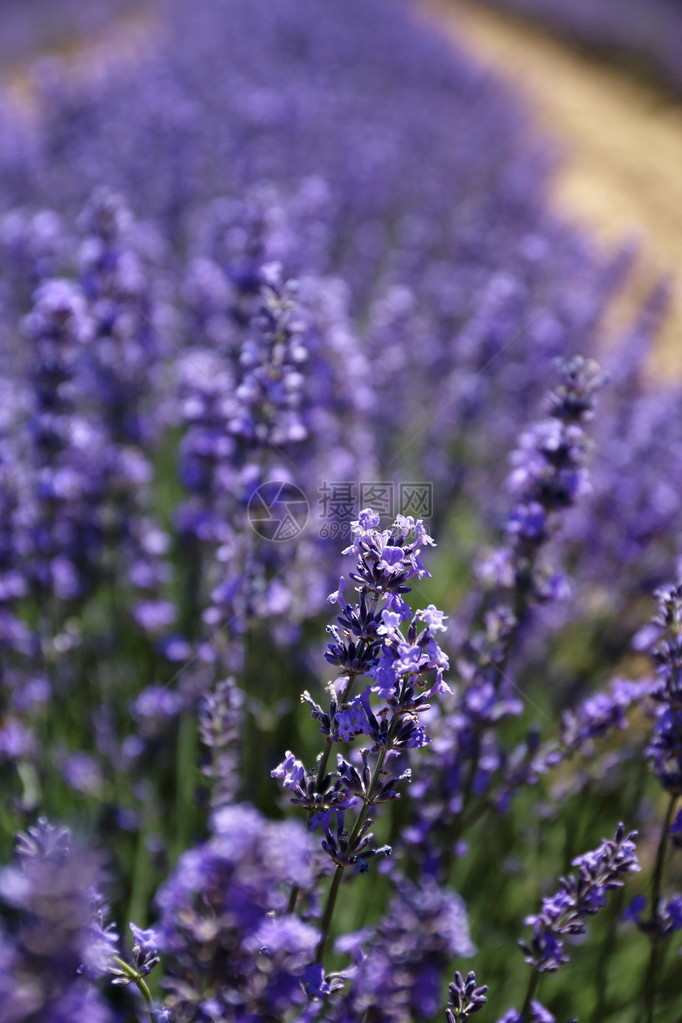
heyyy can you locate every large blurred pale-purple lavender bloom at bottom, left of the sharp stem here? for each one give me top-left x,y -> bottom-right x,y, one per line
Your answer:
158,806 -> 318,1023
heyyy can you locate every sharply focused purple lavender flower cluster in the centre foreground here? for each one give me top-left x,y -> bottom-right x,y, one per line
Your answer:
272,508 -> 449,851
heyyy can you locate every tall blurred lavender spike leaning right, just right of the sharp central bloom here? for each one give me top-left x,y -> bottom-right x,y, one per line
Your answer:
402,357 -> 604,879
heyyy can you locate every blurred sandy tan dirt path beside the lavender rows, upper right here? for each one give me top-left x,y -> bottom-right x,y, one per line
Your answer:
426,0 -> 682,375
